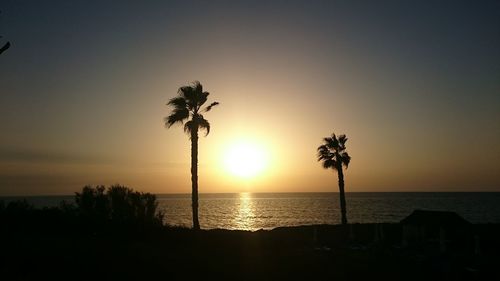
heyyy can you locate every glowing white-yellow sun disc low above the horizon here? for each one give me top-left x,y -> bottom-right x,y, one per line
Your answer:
224,142 -> 268,179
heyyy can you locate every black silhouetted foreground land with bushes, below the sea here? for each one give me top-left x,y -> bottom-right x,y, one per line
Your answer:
0,186 -> 500,280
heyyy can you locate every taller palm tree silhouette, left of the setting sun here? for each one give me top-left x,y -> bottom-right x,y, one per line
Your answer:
165,81 -> 219,230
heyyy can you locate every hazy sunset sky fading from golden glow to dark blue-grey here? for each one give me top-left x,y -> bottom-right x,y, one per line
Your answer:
0,0 -> 500,196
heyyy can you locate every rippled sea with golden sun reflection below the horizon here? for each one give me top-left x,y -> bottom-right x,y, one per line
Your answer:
0,192 -> 500,230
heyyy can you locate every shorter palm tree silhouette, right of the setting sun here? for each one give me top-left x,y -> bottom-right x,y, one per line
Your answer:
318,133 -> 351,224
